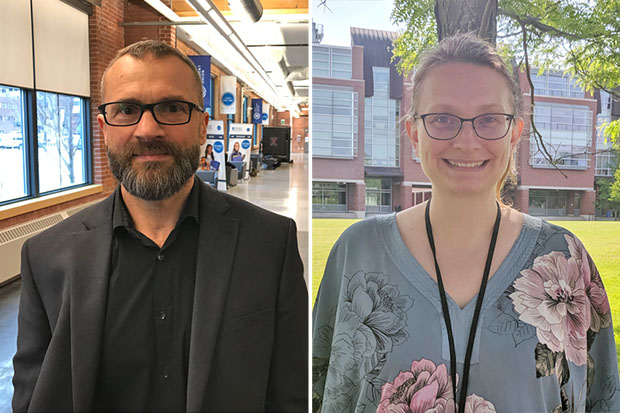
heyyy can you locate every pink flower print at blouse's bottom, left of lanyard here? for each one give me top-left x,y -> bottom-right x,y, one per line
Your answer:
377,359 -> 455,413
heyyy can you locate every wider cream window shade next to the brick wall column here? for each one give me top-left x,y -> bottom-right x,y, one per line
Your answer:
33,0 -> 90,96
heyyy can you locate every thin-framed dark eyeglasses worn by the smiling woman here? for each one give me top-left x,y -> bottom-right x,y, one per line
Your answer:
413,113 -> 515,141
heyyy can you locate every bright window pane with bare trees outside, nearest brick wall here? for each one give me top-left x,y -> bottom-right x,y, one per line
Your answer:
37,92 -> 87,193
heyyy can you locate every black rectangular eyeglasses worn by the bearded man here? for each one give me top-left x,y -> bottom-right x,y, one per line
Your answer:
98,100 -> 204,126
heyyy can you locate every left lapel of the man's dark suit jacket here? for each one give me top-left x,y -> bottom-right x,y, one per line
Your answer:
67,197 -> 113,411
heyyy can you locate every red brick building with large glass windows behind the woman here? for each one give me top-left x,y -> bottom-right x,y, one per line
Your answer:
312,28 -> 615,218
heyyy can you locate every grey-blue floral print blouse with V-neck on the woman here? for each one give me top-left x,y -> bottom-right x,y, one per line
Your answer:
312,215 -> 620,413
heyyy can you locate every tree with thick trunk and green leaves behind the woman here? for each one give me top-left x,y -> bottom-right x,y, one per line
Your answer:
392,0 -> 620,164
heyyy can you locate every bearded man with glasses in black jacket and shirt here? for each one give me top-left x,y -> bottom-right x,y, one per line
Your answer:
13,41 -> 307,411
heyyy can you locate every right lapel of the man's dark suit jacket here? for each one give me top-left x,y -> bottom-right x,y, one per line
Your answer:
187,183 -> 239,412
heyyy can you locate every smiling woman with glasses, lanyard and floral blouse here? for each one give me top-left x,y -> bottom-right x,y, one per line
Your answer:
313,35 -> 620,412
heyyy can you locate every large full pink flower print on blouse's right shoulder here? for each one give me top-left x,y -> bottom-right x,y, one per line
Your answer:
510,251 -> 590,366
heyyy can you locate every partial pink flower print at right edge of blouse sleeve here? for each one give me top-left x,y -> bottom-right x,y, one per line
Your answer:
564,235 -> 611,333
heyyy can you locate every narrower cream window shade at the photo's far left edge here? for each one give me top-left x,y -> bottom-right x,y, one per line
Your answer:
0,0 -> 33,88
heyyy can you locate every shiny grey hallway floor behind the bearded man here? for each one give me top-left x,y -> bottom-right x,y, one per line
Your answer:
0,154 -> 309,412
